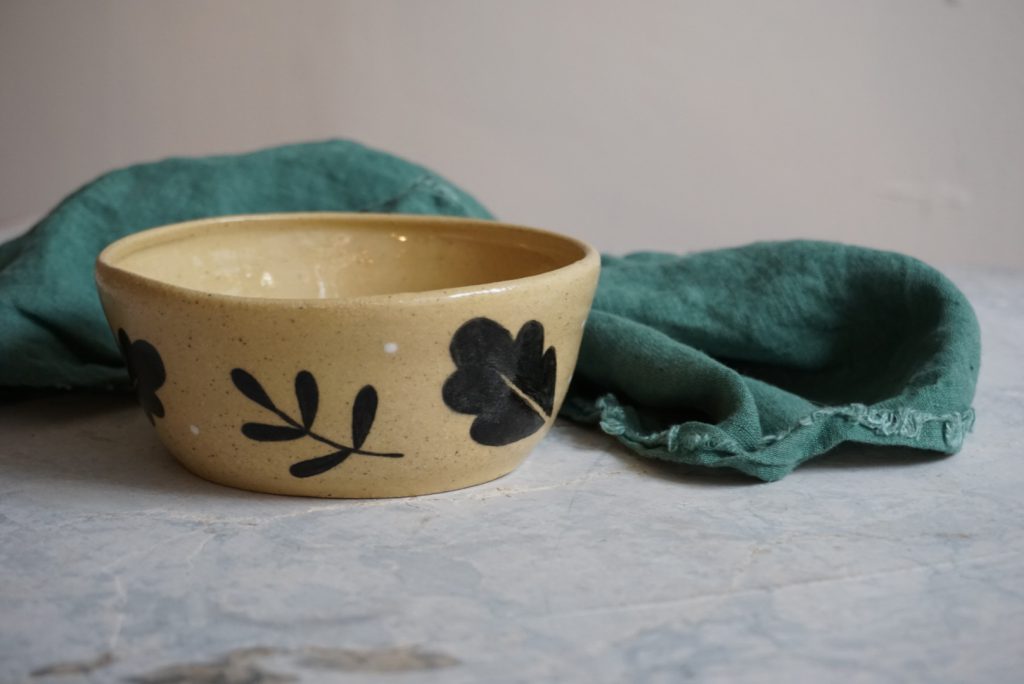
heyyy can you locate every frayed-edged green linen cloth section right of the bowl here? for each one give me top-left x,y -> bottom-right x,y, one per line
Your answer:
562,241 -> 981,481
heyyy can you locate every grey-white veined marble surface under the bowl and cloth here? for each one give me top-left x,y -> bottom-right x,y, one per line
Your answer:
0,270 -> 1024,684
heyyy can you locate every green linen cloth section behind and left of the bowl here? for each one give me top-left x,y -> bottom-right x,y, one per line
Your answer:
0,140 -> 490,388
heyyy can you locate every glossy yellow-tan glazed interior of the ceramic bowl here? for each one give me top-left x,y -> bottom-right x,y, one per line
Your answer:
100,214 -> 587,299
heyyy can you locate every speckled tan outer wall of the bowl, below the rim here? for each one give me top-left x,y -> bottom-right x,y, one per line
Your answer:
97,259 -> 599,498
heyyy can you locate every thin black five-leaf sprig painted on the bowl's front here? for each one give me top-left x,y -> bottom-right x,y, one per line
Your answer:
231,369 -> 403,477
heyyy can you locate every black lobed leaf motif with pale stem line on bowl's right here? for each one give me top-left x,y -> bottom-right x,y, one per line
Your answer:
441,317 -> 557,446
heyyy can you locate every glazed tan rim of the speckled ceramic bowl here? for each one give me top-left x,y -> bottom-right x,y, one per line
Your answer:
94,211 -> 600,308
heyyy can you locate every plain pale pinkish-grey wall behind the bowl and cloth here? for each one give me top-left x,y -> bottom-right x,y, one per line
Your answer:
0,0 -> 1024,265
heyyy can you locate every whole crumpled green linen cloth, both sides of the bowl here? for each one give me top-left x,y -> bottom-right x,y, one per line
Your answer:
0,140 -> 980,480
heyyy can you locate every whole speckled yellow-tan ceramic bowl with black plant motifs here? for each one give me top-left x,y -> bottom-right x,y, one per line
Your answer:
96,213 -> 599,497
